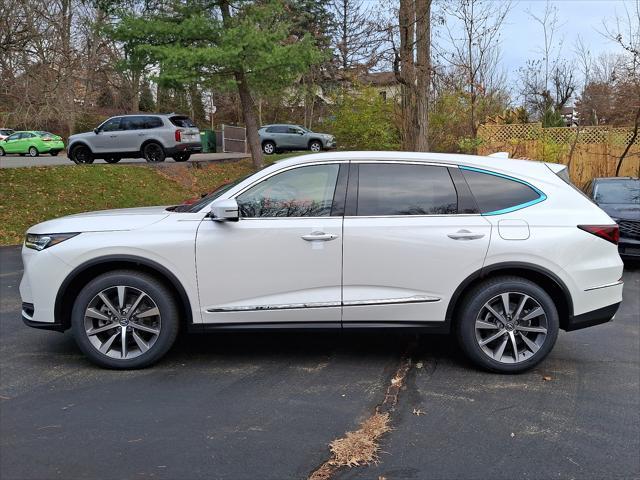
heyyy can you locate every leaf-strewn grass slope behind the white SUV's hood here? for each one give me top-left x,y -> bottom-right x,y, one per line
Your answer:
0,160 -> 253,245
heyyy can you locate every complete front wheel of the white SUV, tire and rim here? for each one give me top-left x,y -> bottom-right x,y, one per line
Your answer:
71,270 -> 179,370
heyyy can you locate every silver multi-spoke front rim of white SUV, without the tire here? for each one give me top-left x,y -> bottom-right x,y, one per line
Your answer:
84,285 -> 162,360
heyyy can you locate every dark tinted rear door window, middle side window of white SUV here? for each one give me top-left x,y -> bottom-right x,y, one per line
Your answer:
357,163 -> 458,216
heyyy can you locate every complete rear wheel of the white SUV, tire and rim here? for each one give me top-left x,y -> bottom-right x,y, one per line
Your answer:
456,277 -> 559,373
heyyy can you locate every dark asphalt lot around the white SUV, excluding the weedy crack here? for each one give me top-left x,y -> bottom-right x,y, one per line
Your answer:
0,247 -> 640,480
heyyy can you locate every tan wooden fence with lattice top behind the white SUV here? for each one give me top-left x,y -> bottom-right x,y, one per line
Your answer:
478,123 -> 640,187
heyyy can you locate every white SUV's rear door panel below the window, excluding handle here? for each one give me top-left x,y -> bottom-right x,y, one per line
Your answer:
342,215 -> 491,322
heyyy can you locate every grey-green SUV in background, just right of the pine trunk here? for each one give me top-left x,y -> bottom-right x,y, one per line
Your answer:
258,124 -> 336,155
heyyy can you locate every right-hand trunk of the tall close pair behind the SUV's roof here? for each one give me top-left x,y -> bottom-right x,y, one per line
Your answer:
415,0 -> 431,152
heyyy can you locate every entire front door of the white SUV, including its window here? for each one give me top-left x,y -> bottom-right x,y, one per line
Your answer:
196,163 -> 348,326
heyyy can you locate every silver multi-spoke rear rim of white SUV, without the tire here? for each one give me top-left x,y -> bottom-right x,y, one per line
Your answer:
475,292 -> 549,363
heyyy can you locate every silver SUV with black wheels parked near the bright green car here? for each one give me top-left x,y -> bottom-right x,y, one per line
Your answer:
68,113 -> 202,164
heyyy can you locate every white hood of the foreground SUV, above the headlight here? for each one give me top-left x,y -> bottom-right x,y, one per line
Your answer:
28,207 -> 170,233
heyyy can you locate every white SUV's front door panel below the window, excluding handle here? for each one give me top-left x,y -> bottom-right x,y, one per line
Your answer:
196,217 -> 342,323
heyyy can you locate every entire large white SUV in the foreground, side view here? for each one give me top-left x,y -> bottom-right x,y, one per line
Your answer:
20,152 -> 623,372
